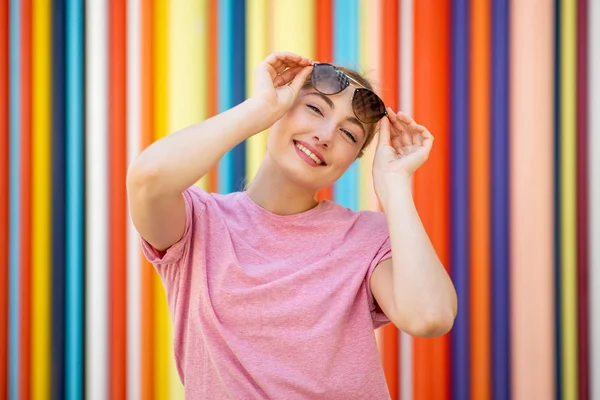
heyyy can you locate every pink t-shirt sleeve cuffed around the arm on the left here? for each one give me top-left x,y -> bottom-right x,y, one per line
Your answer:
140,186 -> 208,266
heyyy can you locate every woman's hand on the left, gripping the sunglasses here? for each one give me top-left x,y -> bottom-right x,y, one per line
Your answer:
253,53 -> 312,122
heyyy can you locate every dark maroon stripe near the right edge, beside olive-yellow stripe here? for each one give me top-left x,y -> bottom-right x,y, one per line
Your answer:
577,0 -> 590,400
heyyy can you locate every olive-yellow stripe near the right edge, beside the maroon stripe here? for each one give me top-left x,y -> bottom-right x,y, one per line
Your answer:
560,0 -> 578,399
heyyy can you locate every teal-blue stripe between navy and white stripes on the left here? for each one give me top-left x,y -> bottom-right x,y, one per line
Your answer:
65,0 -> 84,399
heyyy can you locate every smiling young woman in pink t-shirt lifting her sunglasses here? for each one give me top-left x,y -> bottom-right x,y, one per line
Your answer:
127,53 -> 457,400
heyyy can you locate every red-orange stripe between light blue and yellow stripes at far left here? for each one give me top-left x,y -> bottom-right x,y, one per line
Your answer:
19,0 -> 32,399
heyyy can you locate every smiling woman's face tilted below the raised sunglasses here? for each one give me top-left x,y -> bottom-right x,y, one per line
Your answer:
267,86 -> 367,190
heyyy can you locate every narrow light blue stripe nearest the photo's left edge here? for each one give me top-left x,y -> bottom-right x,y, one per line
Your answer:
8,0 -> 21,400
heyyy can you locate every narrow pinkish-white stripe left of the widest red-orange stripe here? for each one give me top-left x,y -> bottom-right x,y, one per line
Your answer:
398,0 -> 413,400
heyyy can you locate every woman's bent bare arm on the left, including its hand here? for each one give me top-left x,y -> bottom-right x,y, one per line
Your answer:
127,53 -> 311,250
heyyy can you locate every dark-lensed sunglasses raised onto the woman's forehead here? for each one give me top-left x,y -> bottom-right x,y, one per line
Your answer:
310,63 -> 387,124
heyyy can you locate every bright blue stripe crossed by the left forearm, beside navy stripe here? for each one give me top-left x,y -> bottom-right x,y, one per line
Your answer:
217,0 -> 233,193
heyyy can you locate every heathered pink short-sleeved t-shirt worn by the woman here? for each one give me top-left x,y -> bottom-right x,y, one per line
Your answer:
142,187 -> 391,400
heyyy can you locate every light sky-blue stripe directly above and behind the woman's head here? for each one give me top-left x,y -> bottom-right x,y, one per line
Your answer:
333,0 -> 359,211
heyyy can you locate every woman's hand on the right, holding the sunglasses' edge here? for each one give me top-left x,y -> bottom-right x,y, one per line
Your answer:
373,107 -> 433,201
